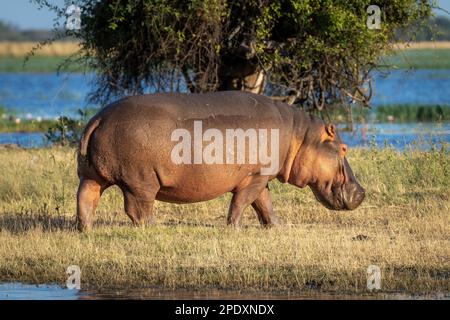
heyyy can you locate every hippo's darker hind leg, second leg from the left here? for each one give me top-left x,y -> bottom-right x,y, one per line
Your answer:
122,174 -> 160,226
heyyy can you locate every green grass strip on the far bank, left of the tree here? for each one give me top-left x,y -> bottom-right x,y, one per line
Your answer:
0,56 -> 83,73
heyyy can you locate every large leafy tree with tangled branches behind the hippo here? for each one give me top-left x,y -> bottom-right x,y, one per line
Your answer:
34,0 -> 435,110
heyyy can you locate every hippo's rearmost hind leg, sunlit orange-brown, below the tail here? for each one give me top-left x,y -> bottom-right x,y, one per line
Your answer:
77,177 -> 104,231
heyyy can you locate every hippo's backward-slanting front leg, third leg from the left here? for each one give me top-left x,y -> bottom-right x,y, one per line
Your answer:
227,176 -> 268,227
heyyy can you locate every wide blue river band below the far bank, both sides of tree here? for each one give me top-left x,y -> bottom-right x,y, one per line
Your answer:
0,69 -> 450,118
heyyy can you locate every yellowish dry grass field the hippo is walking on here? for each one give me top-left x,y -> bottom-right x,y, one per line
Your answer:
0,148 -> 450,294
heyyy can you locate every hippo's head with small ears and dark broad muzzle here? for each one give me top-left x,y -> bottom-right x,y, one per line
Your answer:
288,117 -> 365,210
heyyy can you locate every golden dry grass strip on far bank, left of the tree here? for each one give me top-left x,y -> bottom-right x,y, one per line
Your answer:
0,41 -> 79,57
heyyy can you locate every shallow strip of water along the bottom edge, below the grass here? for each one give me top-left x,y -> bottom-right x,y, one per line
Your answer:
0,283 -> 450,300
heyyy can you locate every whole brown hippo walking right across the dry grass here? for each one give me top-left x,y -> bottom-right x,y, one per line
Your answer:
77,91 -> 365,231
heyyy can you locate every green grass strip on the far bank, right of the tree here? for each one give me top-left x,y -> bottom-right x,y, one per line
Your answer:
380,49 -> 450,69
